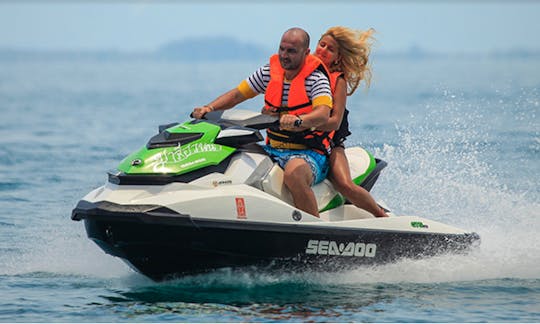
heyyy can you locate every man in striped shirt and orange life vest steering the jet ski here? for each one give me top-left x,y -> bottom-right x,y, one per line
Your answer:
193,28 -> 332,217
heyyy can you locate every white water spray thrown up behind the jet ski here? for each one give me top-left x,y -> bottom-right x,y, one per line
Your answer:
372,93 -> 540,282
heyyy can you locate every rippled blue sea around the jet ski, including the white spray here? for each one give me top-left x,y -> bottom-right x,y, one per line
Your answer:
0,55 -> 540,322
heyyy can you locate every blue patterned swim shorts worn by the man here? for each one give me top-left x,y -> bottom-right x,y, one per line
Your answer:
263,145 -> 328,184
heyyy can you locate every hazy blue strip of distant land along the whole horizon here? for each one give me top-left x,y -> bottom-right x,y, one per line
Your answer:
0,36 -> 540,62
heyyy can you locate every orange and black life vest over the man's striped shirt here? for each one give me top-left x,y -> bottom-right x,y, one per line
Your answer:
264,55 -> 331,154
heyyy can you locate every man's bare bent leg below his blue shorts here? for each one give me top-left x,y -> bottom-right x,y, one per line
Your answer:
283,158 -> 319,217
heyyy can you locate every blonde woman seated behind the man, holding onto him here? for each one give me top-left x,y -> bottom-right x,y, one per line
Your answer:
315,26 -> 388,217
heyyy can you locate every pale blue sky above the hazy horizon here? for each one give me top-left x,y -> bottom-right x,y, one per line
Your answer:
0,0 -> 540,53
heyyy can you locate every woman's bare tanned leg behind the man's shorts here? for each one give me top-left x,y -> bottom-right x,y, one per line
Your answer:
329,147 -> 388,217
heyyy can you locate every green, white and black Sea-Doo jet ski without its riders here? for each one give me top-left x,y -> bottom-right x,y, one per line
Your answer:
71,109 -> 480,281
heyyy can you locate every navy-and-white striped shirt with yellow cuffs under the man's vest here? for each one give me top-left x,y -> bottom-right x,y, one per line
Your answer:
238,64 -> 332,108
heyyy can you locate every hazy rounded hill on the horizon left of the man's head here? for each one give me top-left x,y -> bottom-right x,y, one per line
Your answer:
156,36 -> 272,61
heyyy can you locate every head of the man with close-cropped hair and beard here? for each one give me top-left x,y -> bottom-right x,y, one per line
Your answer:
278,27 -> 309,71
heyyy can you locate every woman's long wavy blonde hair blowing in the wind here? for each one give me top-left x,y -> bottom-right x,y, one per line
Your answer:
321,26 -> 375,96
